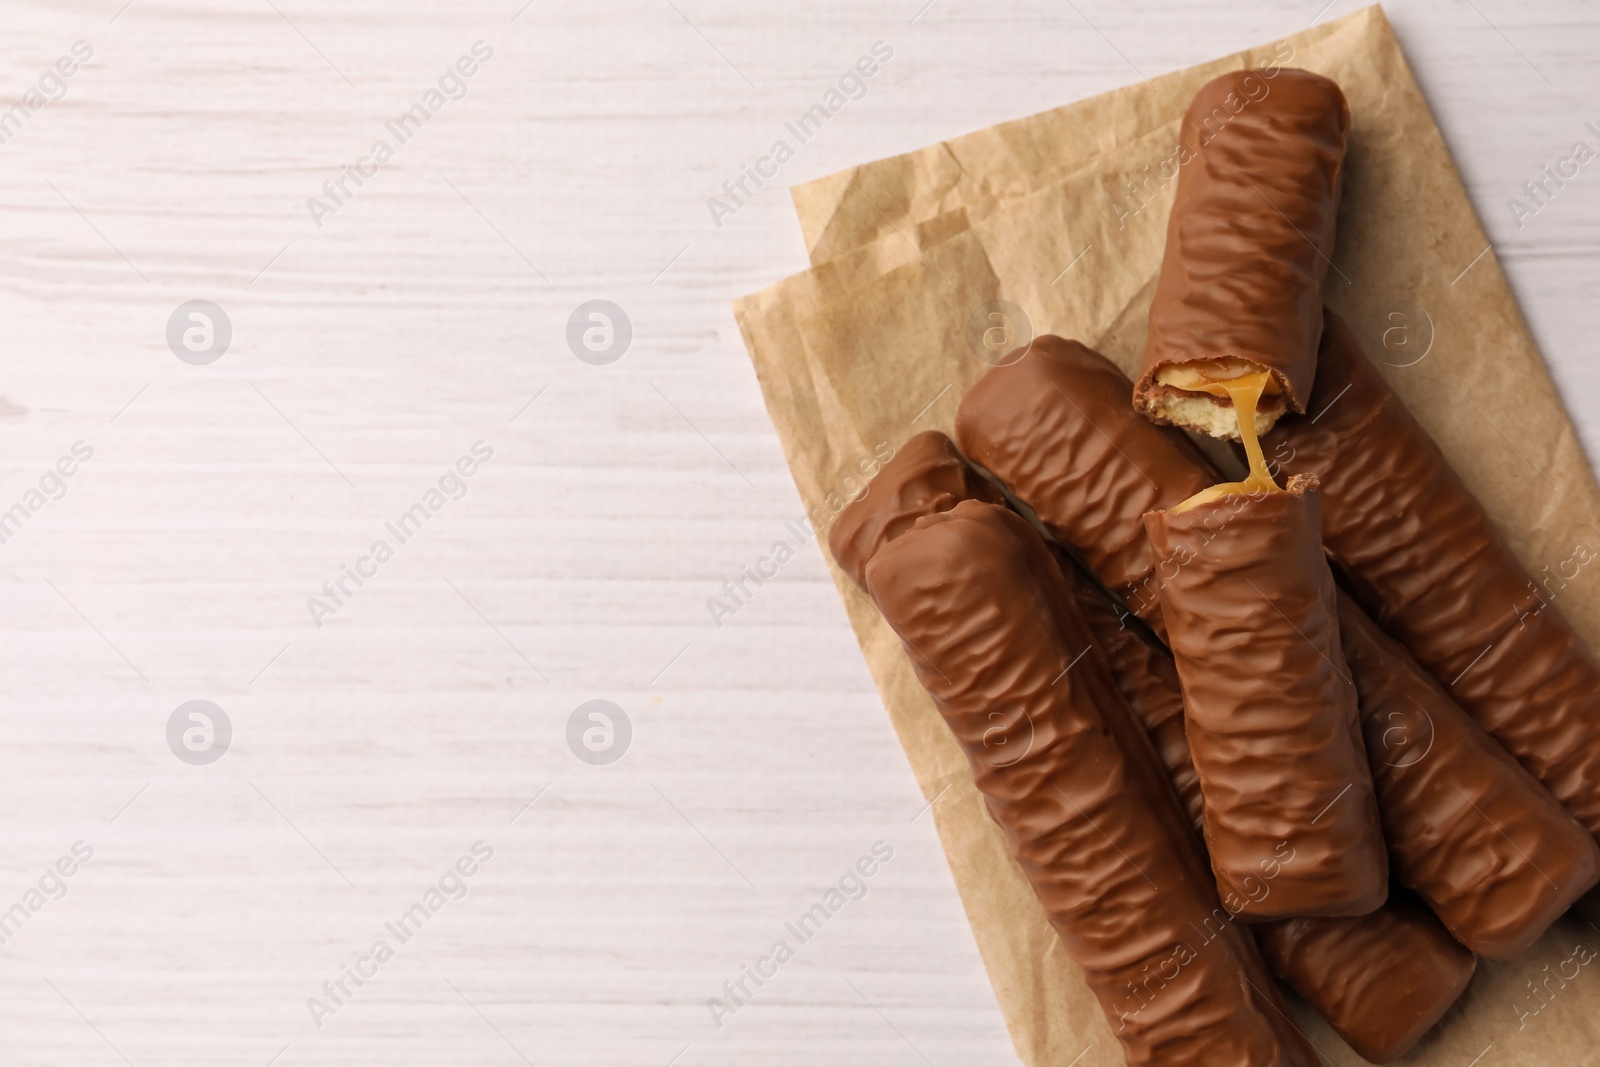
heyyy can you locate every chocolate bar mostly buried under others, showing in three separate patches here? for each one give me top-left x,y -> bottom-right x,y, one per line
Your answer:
835,430 -> 1477,1062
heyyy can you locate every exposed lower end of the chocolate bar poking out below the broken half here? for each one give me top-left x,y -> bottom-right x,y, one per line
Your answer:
1254,889 -> 1477,1064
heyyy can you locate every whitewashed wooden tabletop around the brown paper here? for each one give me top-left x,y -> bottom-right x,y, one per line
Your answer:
0,0 -> 1600,1067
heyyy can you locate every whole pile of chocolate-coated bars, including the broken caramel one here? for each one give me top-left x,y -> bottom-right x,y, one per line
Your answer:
829,70 -> 1600,1067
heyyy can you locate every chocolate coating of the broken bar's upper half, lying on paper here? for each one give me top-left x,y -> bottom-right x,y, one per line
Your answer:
1134,70 -> 1350,411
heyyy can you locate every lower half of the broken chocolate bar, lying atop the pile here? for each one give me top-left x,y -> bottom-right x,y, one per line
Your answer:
1144,478 -> 1389,920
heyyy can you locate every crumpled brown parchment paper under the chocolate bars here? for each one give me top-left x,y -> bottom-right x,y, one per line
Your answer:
734,8 -> 1600,1067
